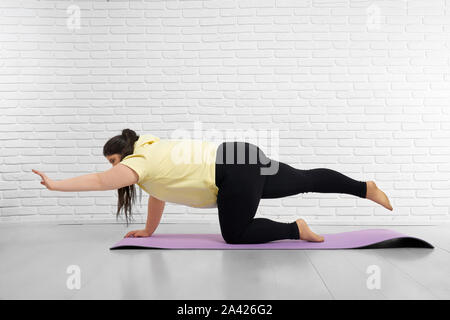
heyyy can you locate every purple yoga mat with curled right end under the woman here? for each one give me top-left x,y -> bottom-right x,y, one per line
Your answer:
110,229 -> 433,250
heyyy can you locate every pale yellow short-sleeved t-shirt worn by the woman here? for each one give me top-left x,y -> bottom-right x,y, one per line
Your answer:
120,134 -> 219,208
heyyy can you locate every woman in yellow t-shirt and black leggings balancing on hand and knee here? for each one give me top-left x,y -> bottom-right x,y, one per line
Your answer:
33,129 -> 392,244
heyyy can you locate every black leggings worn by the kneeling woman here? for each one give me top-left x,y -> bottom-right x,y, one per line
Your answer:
215,141 -> 367,244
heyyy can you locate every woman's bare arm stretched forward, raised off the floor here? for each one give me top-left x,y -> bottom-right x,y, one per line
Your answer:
32,163 -> 139,192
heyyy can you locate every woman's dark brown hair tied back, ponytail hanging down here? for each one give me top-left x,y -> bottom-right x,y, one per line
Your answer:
103,129 -> 142,226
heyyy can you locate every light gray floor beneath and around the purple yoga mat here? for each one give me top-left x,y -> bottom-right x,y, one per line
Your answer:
0,224 -> 450,299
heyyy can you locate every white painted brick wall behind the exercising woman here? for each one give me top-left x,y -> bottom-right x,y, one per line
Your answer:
0,0 -> 450,224
